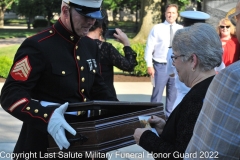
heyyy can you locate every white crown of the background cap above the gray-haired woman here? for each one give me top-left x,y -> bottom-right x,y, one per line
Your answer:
180,11 -> 210,20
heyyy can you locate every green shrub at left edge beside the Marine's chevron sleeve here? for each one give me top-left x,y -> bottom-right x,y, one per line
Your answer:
0,56 -> 13,78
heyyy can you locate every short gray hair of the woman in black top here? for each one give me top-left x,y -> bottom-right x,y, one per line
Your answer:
172,23 -> 223,71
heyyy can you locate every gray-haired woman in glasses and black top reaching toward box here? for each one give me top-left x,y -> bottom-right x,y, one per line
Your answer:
134,23 -> 223,159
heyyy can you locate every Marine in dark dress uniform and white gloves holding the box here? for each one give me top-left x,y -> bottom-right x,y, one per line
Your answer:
0,0 -> 117,159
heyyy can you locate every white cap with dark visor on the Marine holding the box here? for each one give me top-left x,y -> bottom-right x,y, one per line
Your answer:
63,0 -> 104,19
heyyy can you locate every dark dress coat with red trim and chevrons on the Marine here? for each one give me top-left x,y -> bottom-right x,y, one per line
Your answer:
1,20 -> 116,158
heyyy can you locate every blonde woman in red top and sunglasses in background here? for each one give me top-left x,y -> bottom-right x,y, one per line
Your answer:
217,18 -> 240,66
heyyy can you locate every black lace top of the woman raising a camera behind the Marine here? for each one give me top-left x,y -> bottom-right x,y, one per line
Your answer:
95,40 -> 137,97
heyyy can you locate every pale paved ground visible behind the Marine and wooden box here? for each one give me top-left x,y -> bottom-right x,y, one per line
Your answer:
0,82 -> 165,160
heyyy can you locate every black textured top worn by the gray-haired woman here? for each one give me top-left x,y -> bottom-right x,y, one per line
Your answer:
139,76 -> 214,159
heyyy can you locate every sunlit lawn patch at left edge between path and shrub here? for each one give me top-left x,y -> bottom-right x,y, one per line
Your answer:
0,44 -> 20,60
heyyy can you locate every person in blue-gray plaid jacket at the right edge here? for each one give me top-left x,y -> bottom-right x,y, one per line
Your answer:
185,1 -> 240,160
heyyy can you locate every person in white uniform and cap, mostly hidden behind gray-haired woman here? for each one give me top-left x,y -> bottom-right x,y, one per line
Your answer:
166,11 -> 210,112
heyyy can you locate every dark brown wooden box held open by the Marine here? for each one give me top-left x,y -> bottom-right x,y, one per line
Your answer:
48,101 -> 164,153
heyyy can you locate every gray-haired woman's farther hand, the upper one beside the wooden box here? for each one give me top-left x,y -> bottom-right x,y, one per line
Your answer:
148,116 -> 166,135
